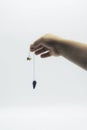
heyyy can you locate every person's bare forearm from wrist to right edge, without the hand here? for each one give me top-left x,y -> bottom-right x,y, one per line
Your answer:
60,40 -> 87,70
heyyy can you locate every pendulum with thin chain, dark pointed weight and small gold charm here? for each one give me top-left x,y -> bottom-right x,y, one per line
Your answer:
27,53 -> 37,89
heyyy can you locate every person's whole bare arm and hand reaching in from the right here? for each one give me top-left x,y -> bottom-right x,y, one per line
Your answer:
30,34 -> 87,70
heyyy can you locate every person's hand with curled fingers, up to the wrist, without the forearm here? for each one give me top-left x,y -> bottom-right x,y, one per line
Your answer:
30,34 -> 61,58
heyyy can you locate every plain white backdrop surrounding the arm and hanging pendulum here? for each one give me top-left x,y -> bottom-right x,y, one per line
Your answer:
0,0 -> 87,130
